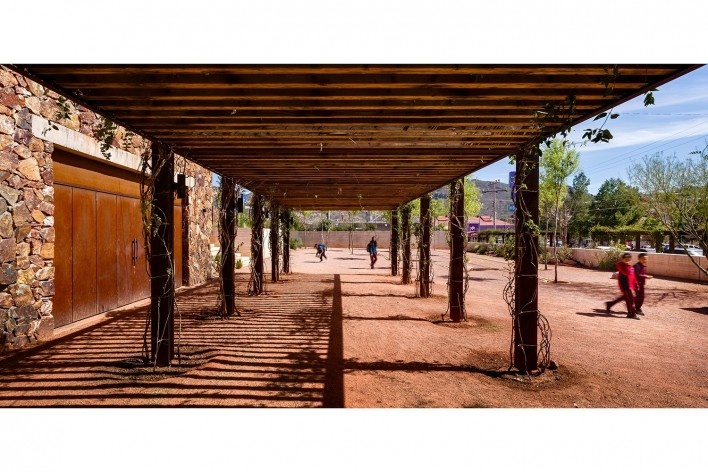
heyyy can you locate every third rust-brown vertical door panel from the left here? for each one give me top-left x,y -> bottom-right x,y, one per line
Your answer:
96,192 -> 119,313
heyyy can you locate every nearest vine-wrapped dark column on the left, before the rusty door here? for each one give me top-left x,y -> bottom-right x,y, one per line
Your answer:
150,143 -> 175,366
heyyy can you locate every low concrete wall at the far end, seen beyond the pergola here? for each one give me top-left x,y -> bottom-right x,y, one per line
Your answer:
290,231 -> 450,253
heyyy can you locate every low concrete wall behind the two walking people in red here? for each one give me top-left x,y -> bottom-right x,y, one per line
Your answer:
573,248 -> 708,282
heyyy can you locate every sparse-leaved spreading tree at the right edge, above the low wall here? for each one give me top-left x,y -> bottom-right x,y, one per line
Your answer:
628,153 -> 708,275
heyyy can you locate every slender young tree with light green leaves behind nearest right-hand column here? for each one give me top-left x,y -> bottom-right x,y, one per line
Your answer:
539,139 -> 580,283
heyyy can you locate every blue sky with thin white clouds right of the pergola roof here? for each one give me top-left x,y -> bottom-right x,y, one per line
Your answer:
473,66 -> 708,194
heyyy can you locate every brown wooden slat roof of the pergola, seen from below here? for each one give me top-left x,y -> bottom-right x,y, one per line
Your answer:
12,64 -> 698,210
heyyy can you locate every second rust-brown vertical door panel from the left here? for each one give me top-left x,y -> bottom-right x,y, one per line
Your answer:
72,188 -> 97,321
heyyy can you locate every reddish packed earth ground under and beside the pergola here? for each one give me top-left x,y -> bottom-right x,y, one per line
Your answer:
0,248 -> 708,408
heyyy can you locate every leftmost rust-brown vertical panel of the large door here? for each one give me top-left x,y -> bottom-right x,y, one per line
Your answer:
52,184 -> 73,327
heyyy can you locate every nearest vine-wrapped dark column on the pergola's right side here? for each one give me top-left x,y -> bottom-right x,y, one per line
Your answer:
513,148 -> 539,373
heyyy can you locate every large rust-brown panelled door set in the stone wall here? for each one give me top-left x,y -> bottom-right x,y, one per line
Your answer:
53,152 -> 182,327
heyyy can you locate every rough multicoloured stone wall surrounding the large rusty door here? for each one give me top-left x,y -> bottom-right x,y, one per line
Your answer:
0,67 -> 212,352
